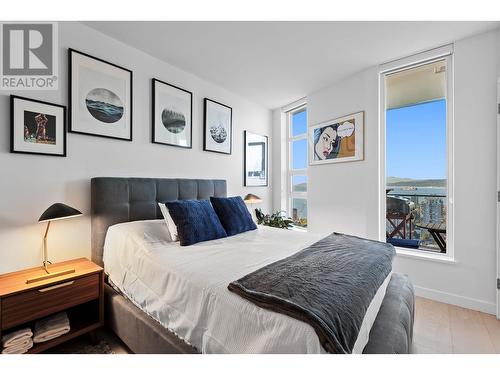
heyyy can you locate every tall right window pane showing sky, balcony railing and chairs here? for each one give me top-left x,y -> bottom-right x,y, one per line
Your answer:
381,48 -> 453,255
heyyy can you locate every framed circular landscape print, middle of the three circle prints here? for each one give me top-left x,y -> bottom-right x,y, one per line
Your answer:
152,78 -> 193,148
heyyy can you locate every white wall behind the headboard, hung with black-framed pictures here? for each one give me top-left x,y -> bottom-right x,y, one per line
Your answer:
0,22 -> 272,273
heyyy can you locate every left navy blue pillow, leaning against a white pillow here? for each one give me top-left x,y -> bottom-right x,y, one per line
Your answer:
165,200 -> 227,246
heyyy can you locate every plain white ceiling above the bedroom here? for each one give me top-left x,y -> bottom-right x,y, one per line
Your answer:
85,21 -> 499,108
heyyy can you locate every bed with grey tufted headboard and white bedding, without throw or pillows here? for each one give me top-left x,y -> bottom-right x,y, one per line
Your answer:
91,177 -> 413,353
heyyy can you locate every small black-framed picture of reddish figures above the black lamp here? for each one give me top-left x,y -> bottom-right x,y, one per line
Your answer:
10,95 -> 66,156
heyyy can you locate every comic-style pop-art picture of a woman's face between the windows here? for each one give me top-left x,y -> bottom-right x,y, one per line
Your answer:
309,111 -> 364,165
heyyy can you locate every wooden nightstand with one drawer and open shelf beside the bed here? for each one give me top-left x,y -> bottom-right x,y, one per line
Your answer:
0,258 -> 104,353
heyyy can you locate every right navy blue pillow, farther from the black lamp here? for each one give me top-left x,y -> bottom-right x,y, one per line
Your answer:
210,197 -> 257,236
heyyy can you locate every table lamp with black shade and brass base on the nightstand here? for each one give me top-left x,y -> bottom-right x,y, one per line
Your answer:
26,203 -> 82,284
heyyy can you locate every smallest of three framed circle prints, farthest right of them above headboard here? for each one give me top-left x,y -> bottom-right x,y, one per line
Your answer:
203,98 -> 233,154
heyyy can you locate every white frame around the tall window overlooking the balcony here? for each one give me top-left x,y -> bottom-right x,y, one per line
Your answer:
378,45 -> 455,263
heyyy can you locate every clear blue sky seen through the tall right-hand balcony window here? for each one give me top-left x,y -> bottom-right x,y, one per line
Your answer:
386,99 -> 446,179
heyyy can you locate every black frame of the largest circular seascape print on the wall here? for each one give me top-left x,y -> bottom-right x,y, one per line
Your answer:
68,48 -> 134,142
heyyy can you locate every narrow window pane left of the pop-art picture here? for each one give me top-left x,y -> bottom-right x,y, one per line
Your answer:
287,106 -> 308,228
